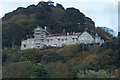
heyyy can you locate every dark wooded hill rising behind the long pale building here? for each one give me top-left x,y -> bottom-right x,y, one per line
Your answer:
2,2 -> 113,47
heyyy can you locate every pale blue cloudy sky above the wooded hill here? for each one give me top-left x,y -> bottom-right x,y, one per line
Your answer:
0,0 -> 120,35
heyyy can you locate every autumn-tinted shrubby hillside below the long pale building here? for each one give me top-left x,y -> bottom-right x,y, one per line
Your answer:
2,37 -> 120,80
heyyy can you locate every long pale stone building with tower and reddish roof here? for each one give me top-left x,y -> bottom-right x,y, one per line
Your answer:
21,26 -> 104,50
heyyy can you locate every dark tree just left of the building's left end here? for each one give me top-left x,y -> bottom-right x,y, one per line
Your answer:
2,23 -> 24,48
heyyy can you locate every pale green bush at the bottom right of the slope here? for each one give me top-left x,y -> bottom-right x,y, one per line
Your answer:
77,70 -> 115,78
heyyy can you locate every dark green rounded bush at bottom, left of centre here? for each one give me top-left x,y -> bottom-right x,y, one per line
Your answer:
33,64 -> 50,78
